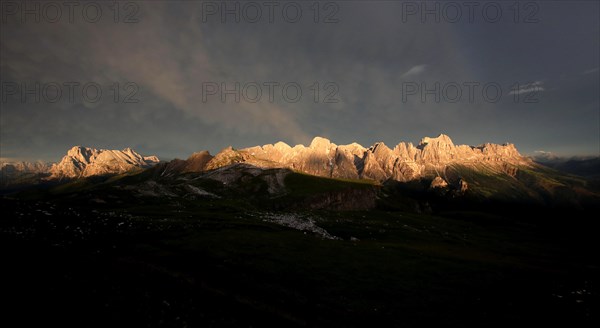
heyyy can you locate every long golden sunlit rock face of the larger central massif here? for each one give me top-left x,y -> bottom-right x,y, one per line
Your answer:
199,134 -> 531,183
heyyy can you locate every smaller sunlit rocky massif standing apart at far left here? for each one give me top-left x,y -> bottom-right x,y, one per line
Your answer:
49,146 -> 159,179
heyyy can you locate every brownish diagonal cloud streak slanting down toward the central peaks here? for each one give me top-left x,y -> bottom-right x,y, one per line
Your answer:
82,3 -> 309,142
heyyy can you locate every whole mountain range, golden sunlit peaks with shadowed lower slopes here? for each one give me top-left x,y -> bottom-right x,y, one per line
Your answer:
1,134 -> 597,207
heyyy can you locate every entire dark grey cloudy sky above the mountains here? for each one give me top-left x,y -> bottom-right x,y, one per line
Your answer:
0,1 -> 600,161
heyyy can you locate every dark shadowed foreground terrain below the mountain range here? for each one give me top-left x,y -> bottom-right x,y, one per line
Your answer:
0,168 -> 600,327
